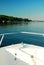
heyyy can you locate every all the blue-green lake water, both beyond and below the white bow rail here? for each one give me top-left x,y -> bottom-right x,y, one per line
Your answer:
0,21 -> 44,46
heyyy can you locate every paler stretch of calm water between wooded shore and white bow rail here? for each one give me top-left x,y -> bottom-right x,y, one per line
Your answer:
0,22 -> 44,33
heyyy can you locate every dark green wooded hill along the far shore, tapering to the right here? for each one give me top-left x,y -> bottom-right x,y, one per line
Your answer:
0,15 -> 32,24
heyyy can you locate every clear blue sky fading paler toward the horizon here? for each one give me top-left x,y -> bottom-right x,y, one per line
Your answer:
0,0 -> 44,20
